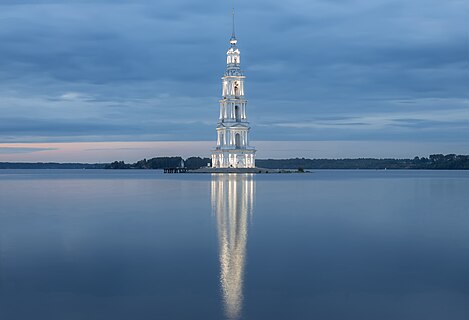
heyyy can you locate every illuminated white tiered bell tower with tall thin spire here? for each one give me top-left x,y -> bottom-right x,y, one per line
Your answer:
212,12 -> 256,168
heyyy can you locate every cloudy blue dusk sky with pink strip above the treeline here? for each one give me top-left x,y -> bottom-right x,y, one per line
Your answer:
0,0 -> 469,162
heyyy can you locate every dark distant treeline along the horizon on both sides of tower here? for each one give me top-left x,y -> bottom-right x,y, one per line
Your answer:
0,154 -> 469,170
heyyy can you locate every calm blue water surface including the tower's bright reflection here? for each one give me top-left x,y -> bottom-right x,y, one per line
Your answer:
0,170 -> 469,320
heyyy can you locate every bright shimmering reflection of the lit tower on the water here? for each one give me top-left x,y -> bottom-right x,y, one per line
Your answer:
211,174 -> 255,320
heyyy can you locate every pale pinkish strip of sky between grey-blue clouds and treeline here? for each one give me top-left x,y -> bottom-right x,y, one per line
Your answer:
0,141 -> 469,163
